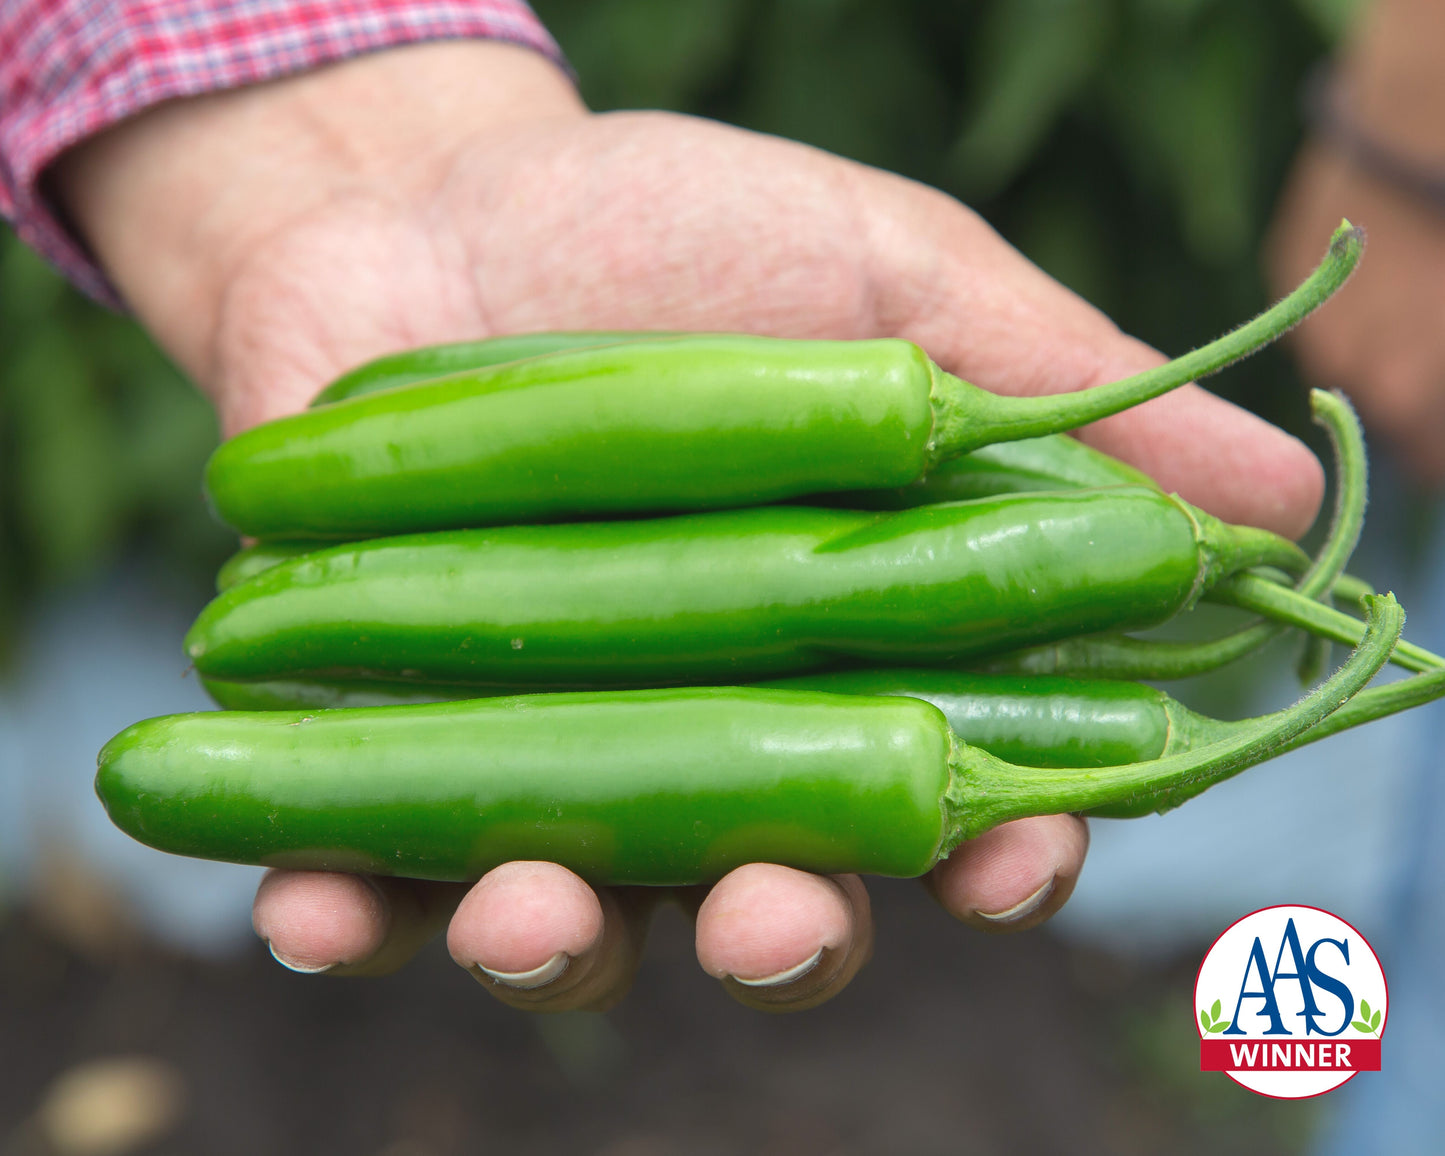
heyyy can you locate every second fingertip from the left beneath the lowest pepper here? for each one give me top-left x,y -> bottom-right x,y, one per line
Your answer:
447,863 -> 660,1012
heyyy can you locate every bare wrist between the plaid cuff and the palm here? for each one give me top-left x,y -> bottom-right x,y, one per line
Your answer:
52,40 -> 585,383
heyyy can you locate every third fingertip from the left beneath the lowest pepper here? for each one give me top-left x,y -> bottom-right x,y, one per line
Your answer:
696,863 -> 873,1012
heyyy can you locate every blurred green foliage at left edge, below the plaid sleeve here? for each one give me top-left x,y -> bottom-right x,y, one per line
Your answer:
0,239 -> 234,657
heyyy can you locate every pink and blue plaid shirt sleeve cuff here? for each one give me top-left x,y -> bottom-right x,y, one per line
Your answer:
0,0 -> 561,305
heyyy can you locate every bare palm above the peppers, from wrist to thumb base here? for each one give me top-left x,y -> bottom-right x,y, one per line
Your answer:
210,114 -> 1127,431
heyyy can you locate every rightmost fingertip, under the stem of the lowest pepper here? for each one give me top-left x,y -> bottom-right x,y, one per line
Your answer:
928,815 -> 1088,932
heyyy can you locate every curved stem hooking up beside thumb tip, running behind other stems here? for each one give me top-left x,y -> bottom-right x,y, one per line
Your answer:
974,389 -> 1374,679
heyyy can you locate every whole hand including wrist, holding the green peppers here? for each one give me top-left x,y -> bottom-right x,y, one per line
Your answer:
56,42 -> 1328,1010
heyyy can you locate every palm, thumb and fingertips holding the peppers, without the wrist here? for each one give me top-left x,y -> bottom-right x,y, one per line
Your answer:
204,106 -> 1318,1009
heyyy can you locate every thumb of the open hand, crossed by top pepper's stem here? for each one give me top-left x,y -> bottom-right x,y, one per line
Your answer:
871,178 -> 1324,538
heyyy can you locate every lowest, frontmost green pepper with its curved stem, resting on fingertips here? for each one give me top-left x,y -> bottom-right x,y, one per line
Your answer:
97,595 -> 1403,884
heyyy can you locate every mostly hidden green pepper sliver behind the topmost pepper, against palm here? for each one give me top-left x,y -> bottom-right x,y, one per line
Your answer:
311,329 -> 682,406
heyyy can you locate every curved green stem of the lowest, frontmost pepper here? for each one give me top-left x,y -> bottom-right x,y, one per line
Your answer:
939,594 -> 1405,857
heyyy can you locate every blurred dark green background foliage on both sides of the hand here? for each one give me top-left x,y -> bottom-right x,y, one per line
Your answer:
0,0 -> 1355,664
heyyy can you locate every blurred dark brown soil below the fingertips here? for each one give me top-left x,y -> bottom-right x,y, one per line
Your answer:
0,881 -> 1322,1156
